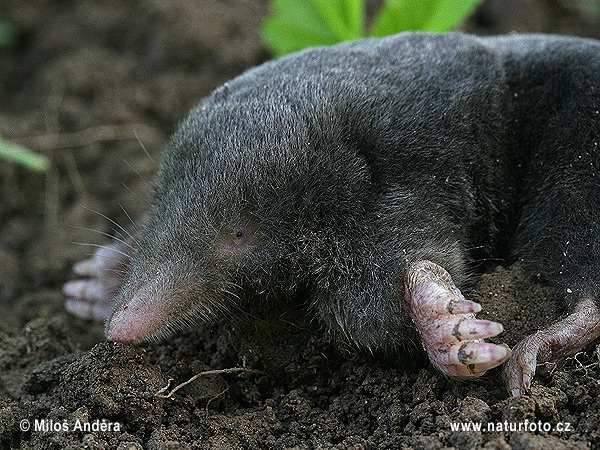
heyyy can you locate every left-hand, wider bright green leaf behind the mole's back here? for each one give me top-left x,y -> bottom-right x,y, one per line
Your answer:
263,0 -> 365,56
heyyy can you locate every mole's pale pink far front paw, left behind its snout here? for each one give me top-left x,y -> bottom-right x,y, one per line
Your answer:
63,245 -> 129,321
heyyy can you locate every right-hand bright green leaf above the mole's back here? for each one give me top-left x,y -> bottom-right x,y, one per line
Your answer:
370,0 -> 482,37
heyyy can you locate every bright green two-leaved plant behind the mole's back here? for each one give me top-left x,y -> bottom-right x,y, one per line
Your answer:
263,0 -> 482,56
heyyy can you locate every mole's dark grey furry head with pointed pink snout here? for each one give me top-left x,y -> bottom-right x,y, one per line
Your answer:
106,96 -> 368,342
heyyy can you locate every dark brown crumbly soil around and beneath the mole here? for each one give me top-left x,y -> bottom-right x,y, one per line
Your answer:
0,0 -> 600,449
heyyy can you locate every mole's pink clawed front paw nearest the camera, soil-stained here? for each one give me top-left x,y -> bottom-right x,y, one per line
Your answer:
405,261 -> 510,378
